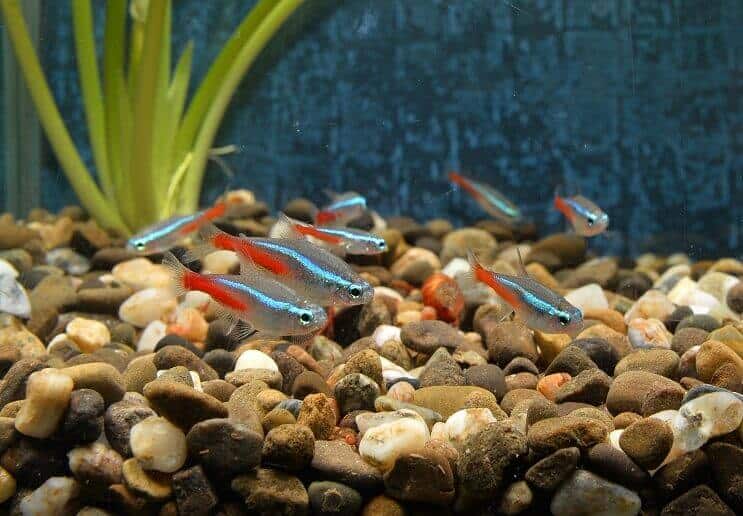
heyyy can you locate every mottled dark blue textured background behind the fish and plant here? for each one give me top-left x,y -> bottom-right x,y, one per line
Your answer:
35,0 -> 743,256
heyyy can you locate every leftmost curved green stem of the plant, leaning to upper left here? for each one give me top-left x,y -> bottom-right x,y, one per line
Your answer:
0,0 -> 129,235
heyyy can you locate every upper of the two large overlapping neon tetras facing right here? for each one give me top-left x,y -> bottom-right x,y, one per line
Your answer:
184,224 -> 374,307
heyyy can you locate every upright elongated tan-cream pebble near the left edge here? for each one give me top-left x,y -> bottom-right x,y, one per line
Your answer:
15,368 -> 74,439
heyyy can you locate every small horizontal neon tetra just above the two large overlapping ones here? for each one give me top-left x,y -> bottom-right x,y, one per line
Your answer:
270,213 -> 387,255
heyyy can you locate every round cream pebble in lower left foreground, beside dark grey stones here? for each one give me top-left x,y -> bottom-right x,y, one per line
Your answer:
129,416 -> 188,473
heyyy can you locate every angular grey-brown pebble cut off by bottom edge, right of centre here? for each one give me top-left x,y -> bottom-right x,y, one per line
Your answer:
550,470 -> 641,516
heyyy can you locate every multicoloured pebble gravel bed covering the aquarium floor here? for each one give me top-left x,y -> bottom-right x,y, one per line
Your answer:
0,196 -> 743,516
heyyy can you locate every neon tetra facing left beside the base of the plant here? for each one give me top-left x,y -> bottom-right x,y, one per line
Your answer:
126,202 -> 227,255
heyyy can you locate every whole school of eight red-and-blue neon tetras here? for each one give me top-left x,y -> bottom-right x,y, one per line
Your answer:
127,172 -> 609,339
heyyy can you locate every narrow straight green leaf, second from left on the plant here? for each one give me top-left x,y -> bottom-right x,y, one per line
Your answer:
72,0 -> 114,201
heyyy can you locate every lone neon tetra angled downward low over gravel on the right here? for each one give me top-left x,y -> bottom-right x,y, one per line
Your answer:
467,250 -> 583,337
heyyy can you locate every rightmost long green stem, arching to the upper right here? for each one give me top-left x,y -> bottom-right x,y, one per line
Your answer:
181,0 -> 303,212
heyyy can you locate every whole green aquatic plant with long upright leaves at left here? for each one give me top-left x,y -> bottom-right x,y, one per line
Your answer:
0,0 -> 303,235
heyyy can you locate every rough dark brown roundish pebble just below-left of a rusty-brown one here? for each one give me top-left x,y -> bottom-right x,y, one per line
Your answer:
262,424 -> 315,471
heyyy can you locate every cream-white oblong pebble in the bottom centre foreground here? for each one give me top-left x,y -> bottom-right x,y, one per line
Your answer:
359,418 -> 429,471
